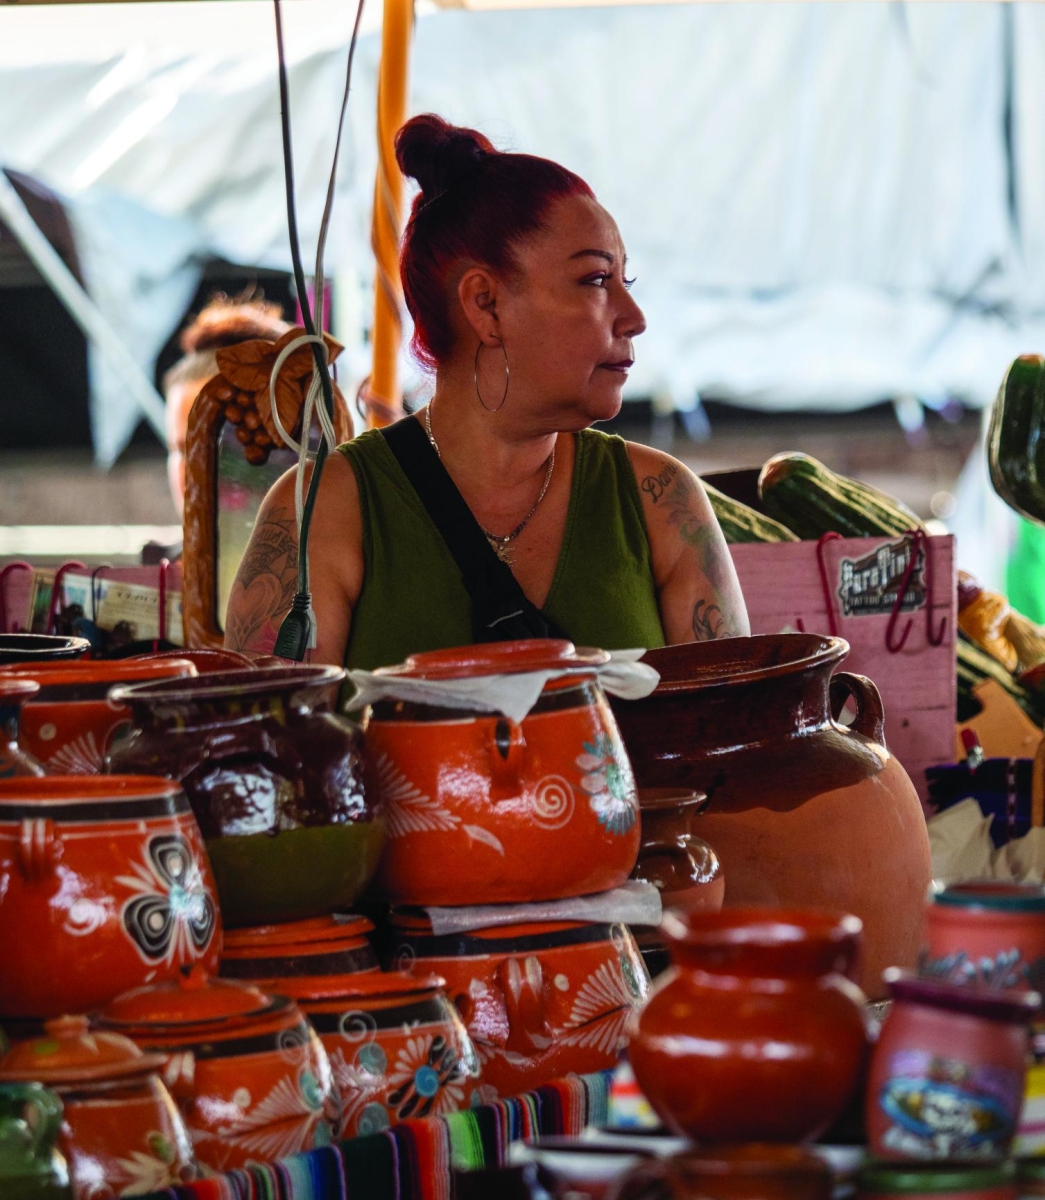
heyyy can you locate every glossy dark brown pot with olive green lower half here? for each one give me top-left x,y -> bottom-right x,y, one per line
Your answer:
106,666 -> 384,926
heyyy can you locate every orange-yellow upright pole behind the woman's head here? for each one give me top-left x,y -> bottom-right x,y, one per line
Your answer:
368,0 -> 414,427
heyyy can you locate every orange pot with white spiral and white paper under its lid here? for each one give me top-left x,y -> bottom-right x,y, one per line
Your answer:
365,640 -> 639,905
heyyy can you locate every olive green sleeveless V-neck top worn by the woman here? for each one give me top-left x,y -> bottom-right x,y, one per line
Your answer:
338,430 -> 665,670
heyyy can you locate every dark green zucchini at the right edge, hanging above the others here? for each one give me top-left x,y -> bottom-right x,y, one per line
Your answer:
987,354 -> 1045,524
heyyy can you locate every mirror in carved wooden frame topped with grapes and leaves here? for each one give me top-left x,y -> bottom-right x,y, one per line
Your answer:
181,329 -> 353,649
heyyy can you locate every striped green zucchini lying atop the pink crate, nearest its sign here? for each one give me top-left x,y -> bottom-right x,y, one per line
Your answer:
758,454 -> 925,540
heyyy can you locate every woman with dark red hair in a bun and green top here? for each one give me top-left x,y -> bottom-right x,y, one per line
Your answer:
226,115 -> 749,668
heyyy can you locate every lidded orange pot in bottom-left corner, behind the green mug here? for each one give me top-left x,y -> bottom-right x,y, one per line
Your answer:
0,1016 -> 197,1200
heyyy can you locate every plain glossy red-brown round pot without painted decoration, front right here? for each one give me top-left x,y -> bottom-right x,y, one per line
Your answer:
629,908 -> 867,1142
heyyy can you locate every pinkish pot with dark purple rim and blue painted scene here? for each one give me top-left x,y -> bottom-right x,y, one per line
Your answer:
866,971 -> 1040,1159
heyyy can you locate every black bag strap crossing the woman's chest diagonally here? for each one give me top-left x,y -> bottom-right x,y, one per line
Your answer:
382,416 -> 566,642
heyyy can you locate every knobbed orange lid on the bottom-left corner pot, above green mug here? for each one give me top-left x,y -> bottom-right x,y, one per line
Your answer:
0,1016 -> 164,1085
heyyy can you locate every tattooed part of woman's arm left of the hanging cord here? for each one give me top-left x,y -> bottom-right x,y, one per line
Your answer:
224,506 -> 298,653
